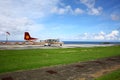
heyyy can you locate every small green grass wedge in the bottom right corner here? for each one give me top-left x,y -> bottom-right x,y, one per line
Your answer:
95,69 -> 120,80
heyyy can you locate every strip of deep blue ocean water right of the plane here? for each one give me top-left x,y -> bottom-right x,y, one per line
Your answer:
63,41 -> 120,44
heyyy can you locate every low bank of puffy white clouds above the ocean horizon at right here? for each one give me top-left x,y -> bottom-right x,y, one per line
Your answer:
77,30 -> 120,40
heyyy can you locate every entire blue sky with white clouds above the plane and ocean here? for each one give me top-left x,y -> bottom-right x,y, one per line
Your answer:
0,0 -> 120,41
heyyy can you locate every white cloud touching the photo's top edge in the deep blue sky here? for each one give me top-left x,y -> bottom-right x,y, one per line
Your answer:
80,0 -> 103,15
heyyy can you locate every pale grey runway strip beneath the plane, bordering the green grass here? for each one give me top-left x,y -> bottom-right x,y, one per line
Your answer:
0,44 -> 120,50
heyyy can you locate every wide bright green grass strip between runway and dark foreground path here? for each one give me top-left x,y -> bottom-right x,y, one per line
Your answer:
0,46 -> 120,73
